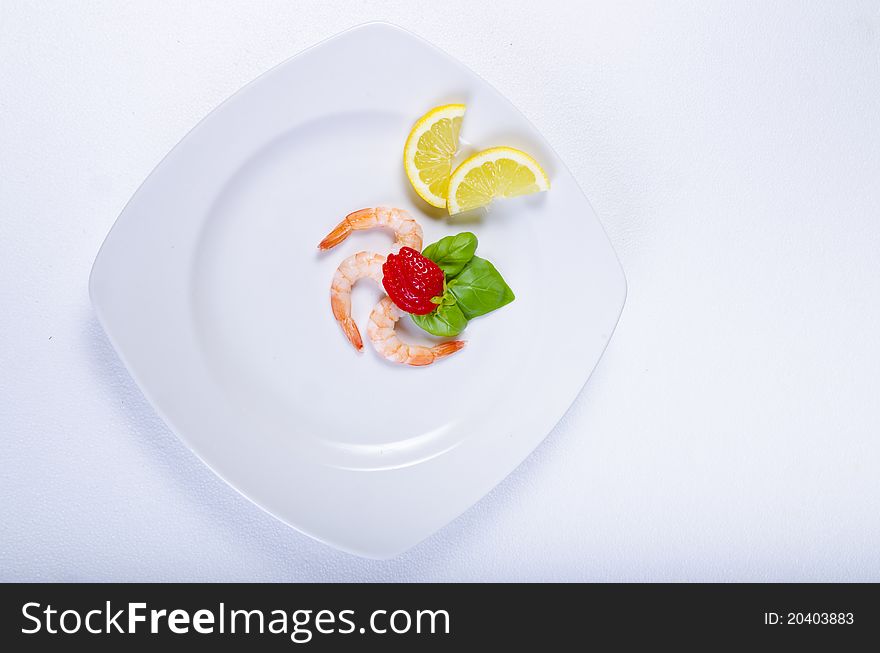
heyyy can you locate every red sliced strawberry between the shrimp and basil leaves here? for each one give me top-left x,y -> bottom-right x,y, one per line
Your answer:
382,247 -> 443,315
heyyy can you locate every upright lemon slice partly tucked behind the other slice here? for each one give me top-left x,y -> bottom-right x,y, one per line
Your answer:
403,104 -> 465,209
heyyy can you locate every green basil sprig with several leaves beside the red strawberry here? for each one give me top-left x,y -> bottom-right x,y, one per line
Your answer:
411,231 -> 515,338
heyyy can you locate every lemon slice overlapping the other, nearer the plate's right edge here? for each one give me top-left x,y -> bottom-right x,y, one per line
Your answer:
447,147 -> 550,214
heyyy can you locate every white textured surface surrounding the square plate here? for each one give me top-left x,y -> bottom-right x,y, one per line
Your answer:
0,0 -> 880,580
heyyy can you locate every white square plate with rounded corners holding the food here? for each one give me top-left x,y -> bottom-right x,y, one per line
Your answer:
90,23 -> 626,558
